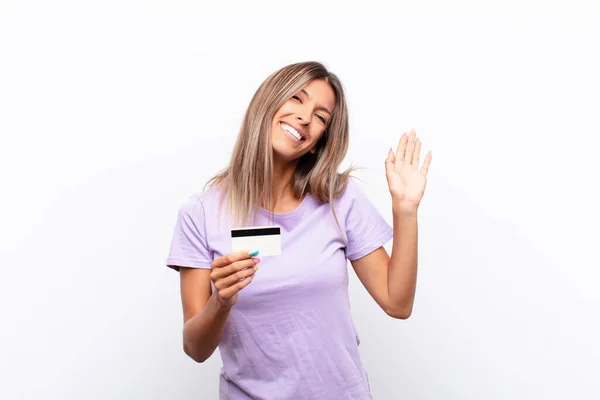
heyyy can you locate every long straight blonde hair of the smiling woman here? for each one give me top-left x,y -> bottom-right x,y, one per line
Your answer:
205,62 -> 356,227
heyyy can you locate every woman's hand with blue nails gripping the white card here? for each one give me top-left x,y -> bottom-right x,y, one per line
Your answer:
210,251 -> 260,308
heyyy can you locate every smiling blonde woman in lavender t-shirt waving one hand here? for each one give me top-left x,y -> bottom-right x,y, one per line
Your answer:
167,62 -> 431,400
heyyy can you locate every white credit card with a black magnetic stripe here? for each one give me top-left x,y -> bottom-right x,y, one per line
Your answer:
231,226 -> 281,257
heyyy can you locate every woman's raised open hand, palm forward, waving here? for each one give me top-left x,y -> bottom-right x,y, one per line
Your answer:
385,129 -> 432,212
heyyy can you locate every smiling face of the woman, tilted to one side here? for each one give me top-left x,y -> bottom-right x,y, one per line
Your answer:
271,79 -> 335,161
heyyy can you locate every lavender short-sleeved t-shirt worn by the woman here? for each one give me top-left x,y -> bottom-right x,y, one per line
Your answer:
167,178 -> 392,400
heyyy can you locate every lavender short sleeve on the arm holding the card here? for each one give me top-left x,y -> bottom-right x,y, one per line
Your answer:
167,194 -> 212,271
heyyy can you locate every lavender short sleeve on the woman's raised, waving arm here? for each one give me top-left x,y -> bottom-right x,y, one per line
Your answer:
345,178 -> 394,261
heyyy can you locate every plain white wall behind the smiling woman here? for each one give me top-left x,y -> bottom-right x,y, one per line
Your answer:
0,0 -> 600,399
